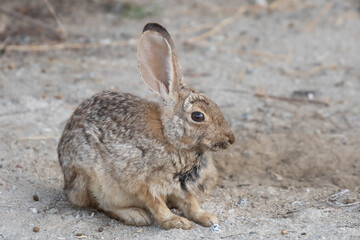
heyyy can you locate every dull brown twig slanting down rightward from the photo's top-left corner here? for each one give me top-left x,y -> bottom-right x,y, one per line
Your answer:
0,6 -> 64,39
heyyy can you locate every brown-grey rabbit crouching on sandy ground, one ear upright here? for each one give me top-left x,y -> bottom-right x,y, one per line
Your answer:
57,23 -> 235,229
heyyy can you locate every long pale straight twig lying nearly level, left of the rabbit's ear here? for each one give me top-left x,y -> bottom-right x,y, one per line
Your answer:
6,39 -> 136,52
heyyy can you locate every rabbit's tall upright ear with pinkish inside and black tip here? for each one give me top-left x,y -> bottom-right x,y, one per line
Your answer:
138,23 -> 182,102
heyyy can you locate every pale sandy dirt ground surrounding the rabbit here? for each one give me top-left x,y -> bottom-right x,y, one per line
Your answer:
0,0 -> 360,240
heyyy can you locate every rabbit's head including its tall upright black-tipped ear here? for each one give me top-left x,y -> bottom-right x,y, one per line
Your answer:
138,23 -> 235,152
